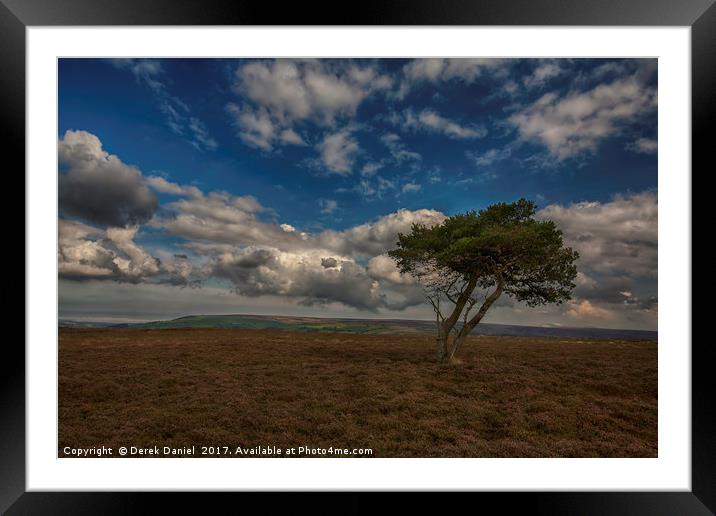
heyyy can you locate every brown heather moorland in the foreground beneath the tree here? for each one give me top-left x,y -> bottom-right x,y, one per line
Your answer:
59,328 -> 657,457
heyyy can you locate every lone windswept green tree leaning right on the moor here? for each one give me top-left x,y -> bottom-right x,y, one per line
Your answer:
388,199 -> 579,362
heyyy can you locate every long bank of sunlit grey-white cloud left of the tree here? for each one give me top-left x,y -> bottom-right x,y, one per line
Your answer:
145,182 -> 445,311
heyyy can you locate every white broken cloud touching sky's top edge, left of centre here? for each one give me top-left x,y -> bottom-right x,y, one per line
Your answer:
227,59 -> 392,150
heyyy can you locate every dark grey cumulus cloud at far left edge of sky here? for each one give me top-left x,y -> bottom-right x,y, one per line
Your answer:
58,130 -> 158,227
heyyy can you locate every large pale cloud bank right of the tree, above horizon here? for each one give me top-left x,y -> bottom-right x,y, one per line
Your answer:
537,192 -> 658,324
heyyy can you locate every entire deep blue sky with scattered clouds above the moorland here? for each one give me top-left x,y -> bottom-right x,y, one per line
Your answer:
58,59 -> 657,329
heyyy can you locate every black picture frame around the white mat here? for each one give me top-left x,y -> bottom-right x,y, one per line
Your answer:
0,0 -> 716,515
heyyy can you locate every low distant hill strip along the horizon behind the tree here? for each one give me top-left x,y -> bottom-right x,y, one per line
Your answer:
59,315 -> 658,340
